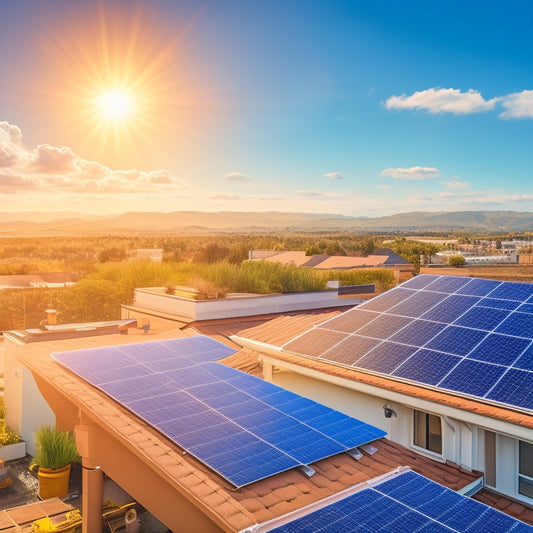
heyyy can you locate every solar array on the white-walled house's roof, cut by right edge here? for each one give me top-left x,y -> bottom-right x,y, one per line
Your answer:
283,274 -> 533,410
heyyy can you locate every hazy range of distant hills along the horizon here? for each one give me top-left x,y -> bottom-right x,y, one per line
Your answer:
0,211 -> 533,235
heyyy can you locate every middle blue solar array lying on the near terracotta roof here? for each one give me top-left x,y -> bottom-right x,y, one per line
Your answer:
52,337 -> 385,487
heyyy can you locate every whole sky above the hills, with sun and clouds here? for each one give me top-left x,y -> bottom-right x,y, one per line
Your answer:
0,0 -> 533,216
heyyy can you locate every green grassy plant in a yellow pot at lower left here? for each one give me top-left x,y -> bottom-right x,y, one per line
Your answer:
30,425 -> 80,500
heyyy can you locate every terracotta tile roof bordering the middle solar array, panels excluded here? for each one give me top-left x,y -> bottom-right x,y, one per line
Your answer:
8,331 -> 490,531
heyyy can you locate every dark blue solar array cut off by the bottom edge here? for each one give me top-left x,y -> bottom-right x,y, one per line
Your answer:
270,471 -> 533,533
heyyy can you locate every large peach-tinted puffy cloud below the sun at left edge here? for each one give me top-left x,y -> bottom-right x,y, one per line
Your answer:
0,122 -> 177,194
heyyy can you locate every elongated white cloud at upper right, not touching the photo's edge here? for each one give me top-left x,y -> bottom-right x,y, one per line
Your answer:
385,88 -> 498,115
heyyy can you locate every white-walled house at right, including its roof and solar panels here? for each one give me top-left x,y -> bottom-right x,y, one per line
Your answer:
232,275 -> 533,505
